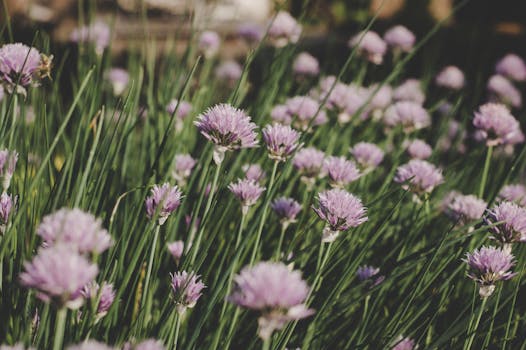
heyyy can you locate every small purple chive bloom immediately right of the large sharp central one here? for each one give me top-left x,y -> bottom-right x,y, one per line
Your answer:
262,124 -> 301,162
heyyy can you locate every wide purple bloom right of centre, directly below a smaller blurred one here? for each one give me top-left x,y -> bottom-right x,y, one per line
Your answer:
394,159 -> 444,195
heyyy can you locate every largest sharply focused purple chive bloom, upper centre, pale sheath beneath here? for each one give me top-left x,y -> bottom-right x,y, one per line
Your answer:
195,104 -> 258,164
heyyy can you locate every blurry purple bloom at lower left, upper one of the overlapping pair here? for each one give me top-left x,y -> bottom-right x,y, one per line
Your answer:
37,208 -> 112,254
